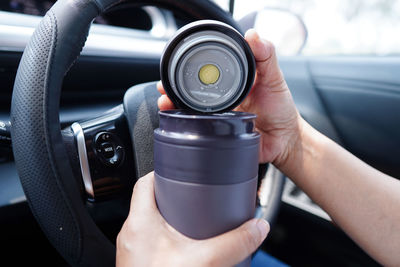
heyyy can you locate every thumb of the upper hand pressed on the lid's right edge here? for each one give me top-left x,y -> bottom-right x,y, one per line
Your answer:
245,29 -> 284,88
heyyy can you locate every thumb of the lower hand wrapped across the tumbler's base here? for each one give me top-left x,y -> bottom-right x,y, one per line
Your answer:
199,219 -> 269,266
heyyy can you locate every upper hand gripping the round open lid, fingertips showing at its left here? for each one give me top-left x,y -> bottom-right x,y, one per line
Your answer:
157,30 -> 302,168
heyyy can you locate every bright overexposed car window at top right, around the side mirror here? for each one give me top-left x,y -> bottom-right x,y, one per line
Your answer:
234,0 -> 400,55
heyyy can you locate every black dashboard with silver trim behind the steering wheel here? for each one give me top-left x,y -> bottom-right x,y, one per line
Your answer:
0,0 -> 330,220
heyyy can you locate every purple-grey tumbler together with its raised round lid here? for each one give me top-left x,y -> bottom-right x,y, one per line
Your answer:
154,20 -> 260,266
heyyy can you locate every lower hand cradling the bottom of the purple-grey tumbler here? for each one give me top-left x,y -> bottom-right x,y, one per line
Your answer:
116,173 -> 269,267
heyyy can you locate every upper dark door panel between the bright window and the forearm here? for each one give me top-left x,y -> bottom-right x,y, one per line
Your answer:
281,57 -> 400,177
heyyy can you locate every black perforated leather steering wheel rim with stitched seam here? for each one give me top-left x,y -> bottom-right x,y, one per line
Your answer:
11,0 -> 241,266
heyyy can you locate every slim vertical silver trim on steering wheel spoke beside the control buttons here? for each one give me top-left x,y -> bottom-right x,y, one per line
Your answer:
71,122 -> 94,198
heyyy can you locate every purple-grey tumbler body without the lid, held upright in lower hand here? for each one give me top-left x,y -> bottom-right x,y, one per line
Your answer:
154,110 -> 260,266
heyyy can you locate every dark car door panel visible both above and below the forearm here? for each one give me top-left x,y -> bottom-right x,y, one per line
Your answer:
266,57 -> 400,266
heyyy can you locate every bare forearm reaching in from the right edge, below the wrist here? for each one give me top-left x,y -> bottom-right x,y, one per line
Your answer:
280,121 -> 400,266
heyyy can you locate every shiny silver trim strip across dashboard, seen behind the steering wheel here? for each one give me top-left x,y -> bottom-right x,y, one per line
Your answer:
0,10 -> 167,59
